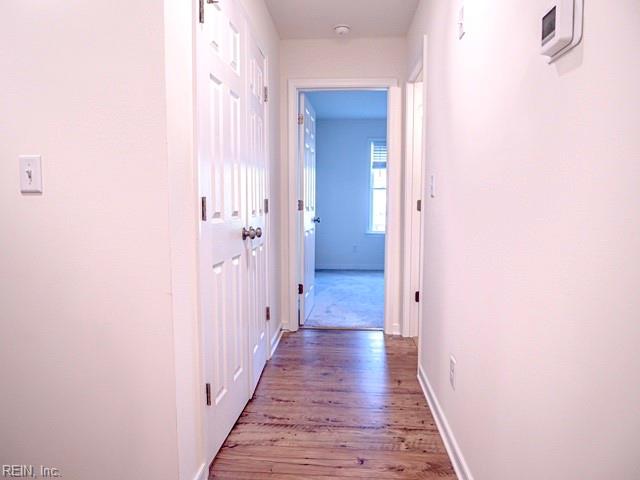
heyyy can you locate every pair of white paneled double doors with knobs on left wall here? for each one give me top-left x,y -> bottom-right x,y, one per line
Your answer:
196,0 -> 266,458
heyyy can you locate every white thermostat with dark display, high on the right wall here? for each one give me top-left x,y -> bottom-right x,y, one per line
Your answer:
541,0 -> 584,63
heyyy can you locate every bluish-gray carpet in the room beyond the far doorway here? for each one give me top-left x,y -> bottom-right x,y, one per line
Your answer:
305,270 -> 384,328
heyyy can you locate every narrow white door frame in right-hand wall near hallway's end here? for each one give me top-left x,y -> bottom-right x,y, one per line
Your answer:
402,51 -> 426,337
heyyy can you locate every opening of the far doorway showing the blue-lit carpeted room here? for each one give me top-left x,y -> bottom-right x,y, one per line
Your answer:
298,89 -> 388,330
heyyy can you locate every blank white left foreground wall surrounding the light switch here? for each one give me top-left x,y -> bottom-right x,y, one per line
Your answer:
0,0 -> 178,480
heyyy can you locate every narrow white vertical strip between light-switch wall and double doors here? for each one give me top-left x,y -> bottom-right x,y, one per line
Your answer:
164,0 -> 200,480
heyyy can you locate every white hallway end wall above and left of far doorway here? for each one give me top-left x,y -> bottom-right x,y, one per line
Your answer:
280,38 -> 407,329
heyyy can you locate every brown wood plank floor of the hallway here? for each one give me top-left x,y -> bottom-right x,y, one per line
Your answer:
209,330 -> 456,480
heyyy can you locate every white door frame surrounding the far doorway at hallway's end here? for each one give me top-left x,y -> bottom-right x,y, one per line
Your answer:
283,78 -> 402,335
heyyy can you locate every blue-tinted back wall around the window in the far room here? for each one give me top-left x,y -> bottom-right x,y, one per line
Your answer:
316,119 -> 387,270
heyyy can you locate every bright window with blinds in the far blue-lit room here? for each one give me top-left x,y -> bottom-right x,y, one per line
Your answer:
369,140 -> 387,233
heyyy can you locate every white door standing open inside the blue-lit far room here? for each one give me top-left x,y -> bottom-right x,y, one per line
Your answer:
299,93 -> 318,324
